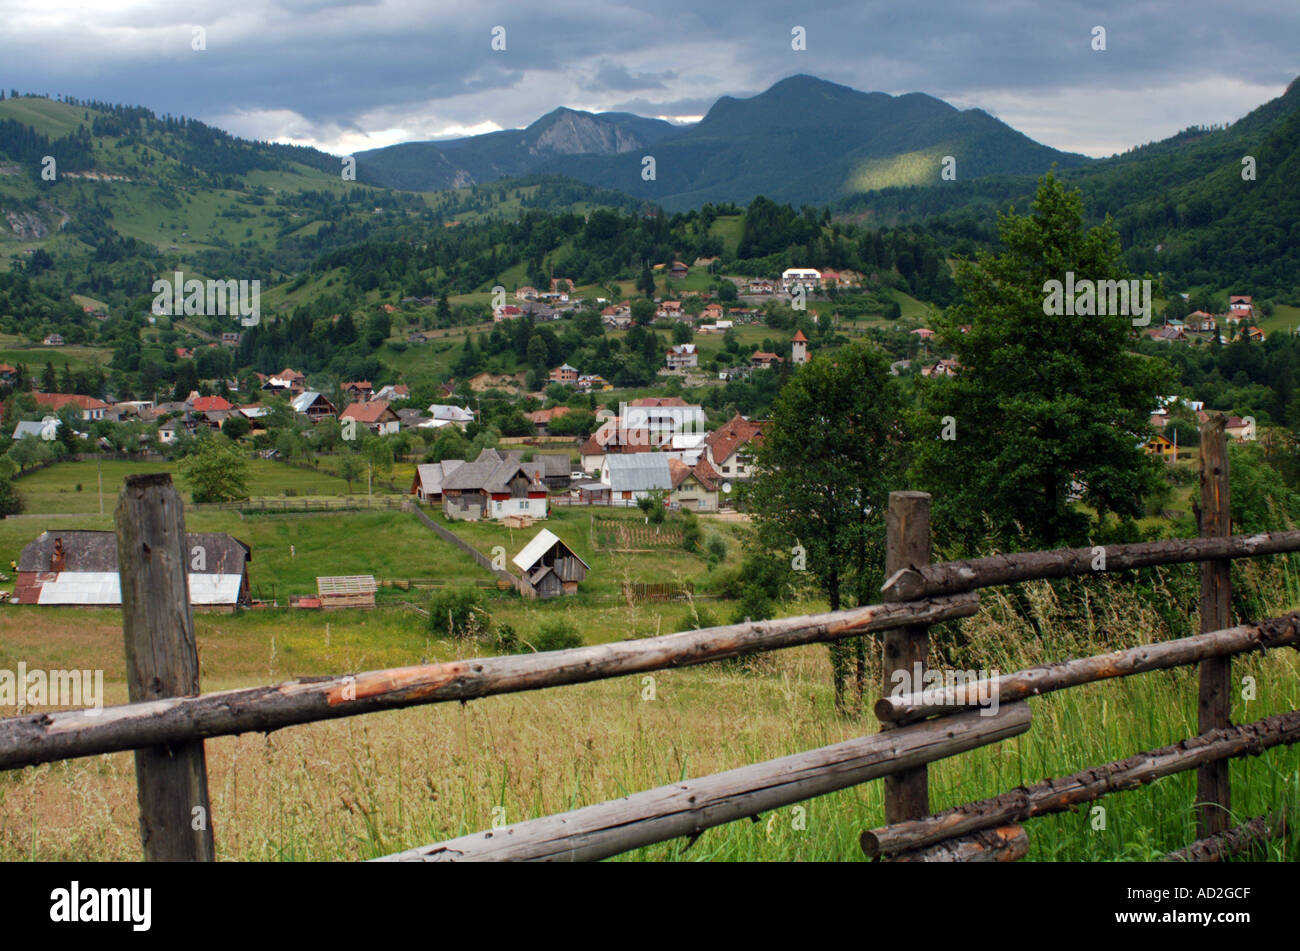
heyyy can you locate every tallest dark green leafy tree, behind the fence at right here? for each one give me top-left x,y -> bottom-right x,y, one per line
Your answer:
911,173 -> 1171,550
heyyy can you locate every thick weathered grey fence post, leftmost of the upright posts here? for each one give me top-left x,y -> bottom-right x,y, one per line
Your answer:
116,473 -> 213,861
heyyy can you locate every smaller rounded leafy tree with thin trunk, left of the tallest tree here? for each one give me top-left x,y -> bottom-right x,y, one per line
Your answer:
749,343 -> 904,711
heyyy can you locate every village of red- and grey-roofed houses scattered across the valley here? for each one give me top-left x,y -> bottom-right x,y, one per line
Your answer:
0,259 -> 1262,609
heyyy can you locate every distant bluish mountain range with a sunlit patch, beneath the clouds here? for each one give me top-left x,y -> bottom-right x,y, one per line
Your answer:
359,75 -> 1089,209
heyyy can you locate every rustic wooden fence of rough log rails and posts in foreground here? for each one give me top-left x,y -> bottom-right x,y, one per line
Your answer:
0,418 -> 1300,861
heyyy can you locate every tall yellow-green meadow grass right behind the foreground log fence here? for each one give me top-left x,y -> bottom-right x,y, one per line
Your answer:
0,569 -> 1300,861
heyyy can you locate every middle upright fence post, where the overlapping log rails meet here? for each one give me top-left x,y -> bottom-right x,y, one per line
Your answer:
880,492 -> 931,824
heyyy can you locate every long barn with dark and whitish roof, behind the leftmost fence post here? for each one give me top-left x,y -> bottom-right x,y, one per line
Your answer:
13,531 -> 252,611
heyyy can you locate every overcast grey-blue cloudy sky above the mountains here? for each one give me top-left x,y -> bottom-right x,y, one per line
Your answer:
0,0 -> 1300,156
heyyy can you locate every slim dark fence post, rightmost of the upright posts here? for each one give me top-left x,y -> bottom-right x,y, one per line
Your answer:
1196,416 -> 1232,839
